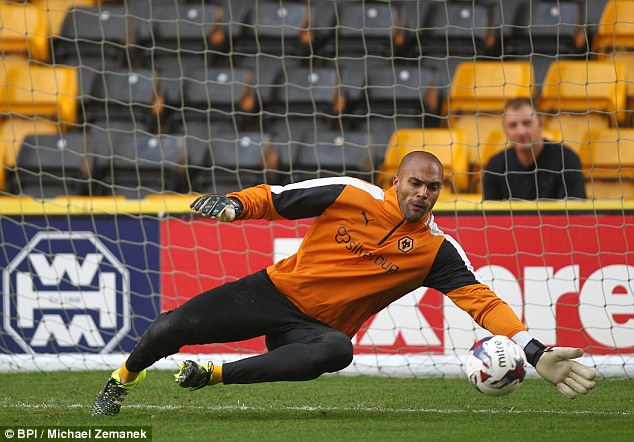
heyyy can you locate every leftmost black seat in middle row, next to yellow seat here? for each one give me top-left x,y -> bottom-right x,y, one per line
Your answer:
82,69 -> 163,129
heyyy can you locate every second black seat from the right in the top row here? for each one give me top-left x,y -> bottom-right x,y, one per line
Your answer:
414,1 -> 499,57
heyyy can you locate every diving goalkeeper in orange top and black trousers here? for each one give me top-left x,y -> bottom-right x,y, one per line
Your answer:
92,151 -> 595,415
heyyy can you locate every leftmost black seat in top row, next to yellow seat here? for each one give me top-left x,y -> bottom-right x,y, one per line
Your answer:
52,5 -> 137,70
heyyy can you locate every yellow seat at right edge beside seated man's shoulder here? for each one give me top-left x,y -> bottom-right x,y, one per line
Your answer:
579,128 -> 634,199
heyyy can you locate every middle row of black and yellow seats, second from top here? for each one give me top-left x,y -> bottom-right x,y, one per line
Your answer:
0,56 -> 634,125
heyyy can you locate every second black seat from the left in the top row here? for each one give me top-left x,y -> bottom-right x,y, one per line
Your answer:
135,2 -> 223,68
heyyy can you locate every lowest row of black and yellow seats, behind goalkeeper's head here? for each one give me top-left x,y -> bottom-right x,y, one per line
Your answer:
7,123 -> 634,198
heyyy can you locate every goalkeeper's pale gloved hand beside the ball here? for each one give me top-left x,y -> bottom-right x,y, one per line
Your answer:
535,347 -> 597,399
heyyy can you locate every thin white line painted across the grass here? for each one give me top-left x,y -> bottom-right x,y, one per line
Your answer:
2,401 -> 631,416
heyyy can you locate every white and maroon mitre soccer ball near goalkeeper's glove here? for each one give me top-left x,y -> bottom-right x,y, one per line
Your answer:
467,335 -> 527,396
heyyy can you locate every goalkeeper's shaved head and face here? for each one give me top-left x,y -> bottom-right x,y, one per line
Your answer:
394,150 -> 444,222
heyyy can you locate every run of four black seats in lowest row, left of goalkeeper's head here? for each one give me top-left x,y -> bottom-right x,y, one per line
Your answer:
0,129 -> 373,198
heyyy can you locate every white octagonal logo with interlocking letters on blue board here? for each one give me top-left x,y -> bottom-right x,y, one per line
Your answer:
3,232 -> 130,353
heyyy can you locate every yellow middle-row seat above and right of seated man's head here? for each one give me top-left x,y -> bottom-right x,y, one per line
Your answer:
539,60 -> 628,122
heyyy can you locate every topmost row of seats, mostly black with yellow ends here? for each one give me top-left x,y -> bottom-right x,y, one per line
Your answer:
0,0 -> 616,66
